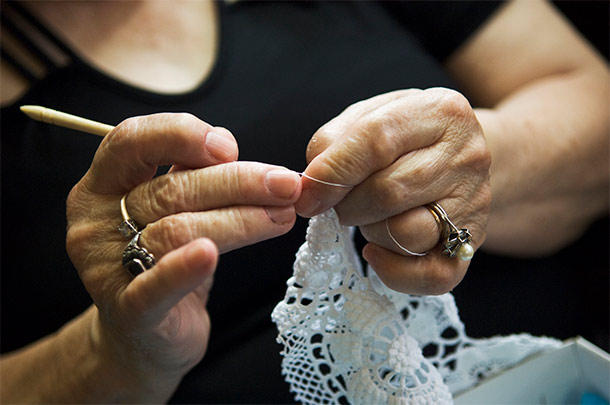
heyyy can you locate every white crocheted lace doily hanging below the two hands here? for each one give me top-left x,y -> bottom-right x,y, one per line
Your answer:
272,210 -> 560,404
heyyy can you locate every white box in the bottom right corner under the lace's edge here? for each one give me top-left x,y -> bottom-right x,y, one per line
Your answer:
454,337 -> 610,405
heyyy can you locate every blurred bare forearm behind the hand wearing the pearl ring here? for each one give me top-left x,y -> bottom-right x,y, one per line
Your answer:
475,105 -> 608,252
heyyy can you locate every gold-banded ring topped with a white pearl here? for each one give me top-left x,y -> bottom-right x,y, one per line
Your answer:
426,203 -> 474,261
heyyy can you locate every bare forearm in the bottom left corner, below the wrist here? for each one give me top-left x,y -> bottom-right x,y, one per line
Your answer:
1,306 -> 160,403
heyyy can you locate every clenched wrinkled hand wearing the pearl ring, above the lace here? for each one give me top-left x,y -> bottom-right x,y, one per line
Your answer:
296,88 -> 491,294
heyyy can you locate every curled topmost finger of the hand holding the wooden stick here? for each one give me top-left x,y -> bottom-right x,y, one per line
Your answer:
83,113 -> 238,194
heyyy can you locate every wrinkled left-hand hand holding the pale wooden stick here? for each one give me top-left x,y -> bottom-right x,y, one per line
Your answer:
67,114 -> 301,401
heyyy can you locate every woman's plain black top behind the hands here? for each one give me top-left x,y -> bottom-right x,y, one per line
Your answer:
1,1 -> 607,403
